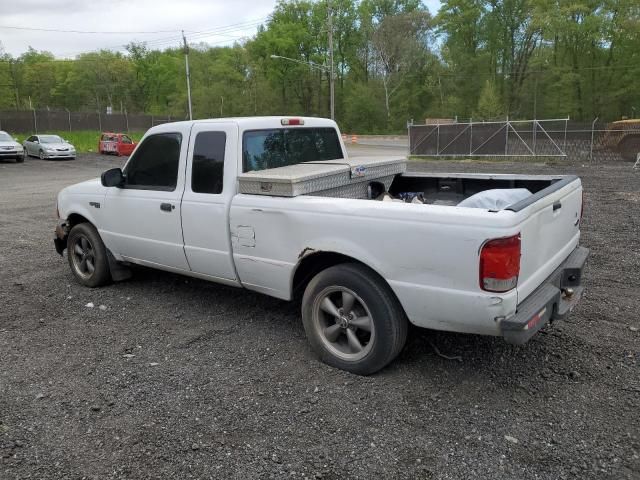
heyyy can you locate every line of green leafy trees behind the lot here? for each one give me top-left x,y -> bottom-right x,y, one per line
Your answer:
0,0 -> 640,133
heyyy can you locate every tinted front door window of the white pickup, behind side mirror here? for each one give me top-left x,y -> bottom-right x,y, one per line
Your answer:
124,133 -> 182,191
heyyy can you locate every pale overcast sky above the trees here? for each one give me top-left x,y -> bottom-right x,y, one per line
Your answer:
0,0 -> 440,58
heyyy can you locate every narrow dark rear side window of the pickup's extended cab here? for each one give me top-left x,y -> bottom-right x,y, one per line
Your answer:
191,132 -> 227,193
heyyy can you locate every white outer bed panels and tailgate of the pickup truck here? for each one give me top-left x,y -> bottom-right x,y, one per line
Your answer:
231,173 -> 582,335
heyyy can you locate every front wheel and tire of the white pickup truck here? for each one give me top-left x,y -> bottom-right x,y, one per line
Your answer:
67,223 -> 111,288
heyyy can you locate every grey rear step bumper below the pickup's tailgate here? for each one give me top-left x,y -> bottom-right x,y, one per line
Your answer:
500,247 -> 589,345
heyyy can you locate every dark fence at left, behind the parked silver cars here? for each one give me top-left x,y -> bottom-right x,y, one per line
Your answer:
0,110 -> 180,134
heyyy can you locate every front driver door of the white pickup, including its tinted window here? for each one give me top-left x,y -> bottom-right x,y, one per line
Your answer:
100,126 -> 190,270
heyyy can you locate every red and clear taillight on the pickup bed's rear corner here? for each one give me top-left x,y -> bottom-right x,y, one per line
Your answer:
480,234 -> 520,292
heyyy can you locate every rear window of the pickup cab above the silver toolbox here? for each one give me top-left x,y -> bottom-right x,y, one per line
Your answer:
242,128 -> 343,172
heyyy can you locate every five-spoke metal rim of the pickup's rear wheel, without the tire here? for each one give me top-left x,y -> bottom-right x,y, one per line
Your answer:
313,286 -> 375,361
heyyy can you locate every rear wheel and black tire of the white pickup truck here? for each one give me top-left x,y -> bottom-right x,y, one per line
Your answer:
302,263 -> 408,375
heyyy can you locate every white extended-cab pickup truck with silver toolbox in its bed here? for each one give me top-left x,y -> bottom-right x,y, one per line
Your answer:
55,117 -> 588,375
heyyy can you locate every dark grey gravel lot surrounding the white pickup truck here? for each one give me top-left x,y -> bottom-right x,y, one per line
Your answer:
0,156 -> 640,480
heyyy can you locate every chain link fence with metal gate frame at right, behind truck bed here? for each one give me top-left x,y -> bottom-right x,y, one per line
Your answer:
408,118 -> 640,161
